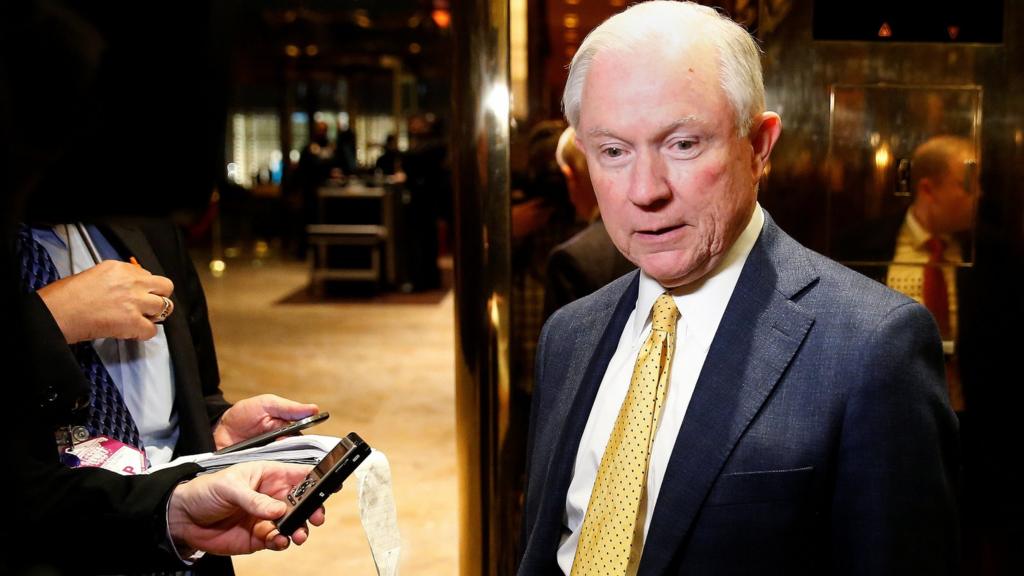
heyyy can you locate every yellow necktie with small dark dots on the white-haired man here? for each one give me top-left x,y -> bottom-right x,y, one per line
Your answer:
571,294 -> 679,576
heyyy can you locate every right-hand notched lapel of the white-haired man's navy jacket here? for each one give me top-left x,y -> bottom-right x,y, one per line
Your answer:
639,214 -> 817,575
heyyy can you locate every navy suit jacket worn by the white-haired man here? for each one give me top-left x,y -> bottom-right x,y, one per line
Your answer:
519,212 -> 958,576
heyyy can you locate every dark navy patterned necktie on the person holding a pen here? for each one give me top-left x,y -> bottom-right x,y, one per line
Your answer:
14,224 -> 142,448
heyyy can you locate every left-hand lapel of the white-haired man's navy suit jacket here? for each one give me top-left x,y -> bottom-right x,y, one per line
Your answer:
523,274 -> 640,573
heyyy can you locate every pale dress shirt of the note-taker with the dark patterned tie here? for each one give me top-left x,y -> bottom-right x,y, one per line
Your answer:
32,224 -> 179,465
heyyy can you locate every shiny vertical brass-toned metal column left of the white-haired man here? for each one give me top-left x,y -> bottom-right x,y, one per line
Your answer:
452,0 -> 512,576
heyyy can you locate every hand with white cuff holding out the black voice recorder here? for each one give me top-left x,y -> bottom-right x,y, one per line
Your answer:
167,461 -> 325,558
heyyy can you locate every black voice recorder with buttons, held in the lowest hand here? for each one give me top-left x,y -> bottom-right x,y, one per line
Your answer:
276,433 -> 370,536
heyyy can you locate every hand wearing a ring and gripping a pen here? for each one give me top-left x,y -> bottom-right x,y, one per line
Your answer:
38,260 -> 174,344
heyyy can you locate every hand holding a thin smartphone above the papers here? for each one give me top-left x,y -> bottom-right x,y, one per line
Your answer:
213,394 -> 319,450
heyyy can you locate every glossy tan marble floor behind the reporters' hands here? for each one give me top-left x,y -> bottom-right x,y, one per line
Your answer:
197,257 -> 458,576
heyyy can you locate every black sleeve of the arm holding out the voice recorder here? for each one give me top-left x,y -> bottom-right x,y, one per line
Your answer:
11,294 -> 199,574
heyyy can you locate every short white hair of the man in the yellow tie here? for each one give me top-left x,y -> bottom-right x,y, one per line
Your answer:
562,0 -> 765,136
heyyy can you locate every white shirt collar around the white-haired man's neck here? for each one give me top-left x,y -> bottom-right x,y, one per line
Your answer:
633,203 -> 765,341
